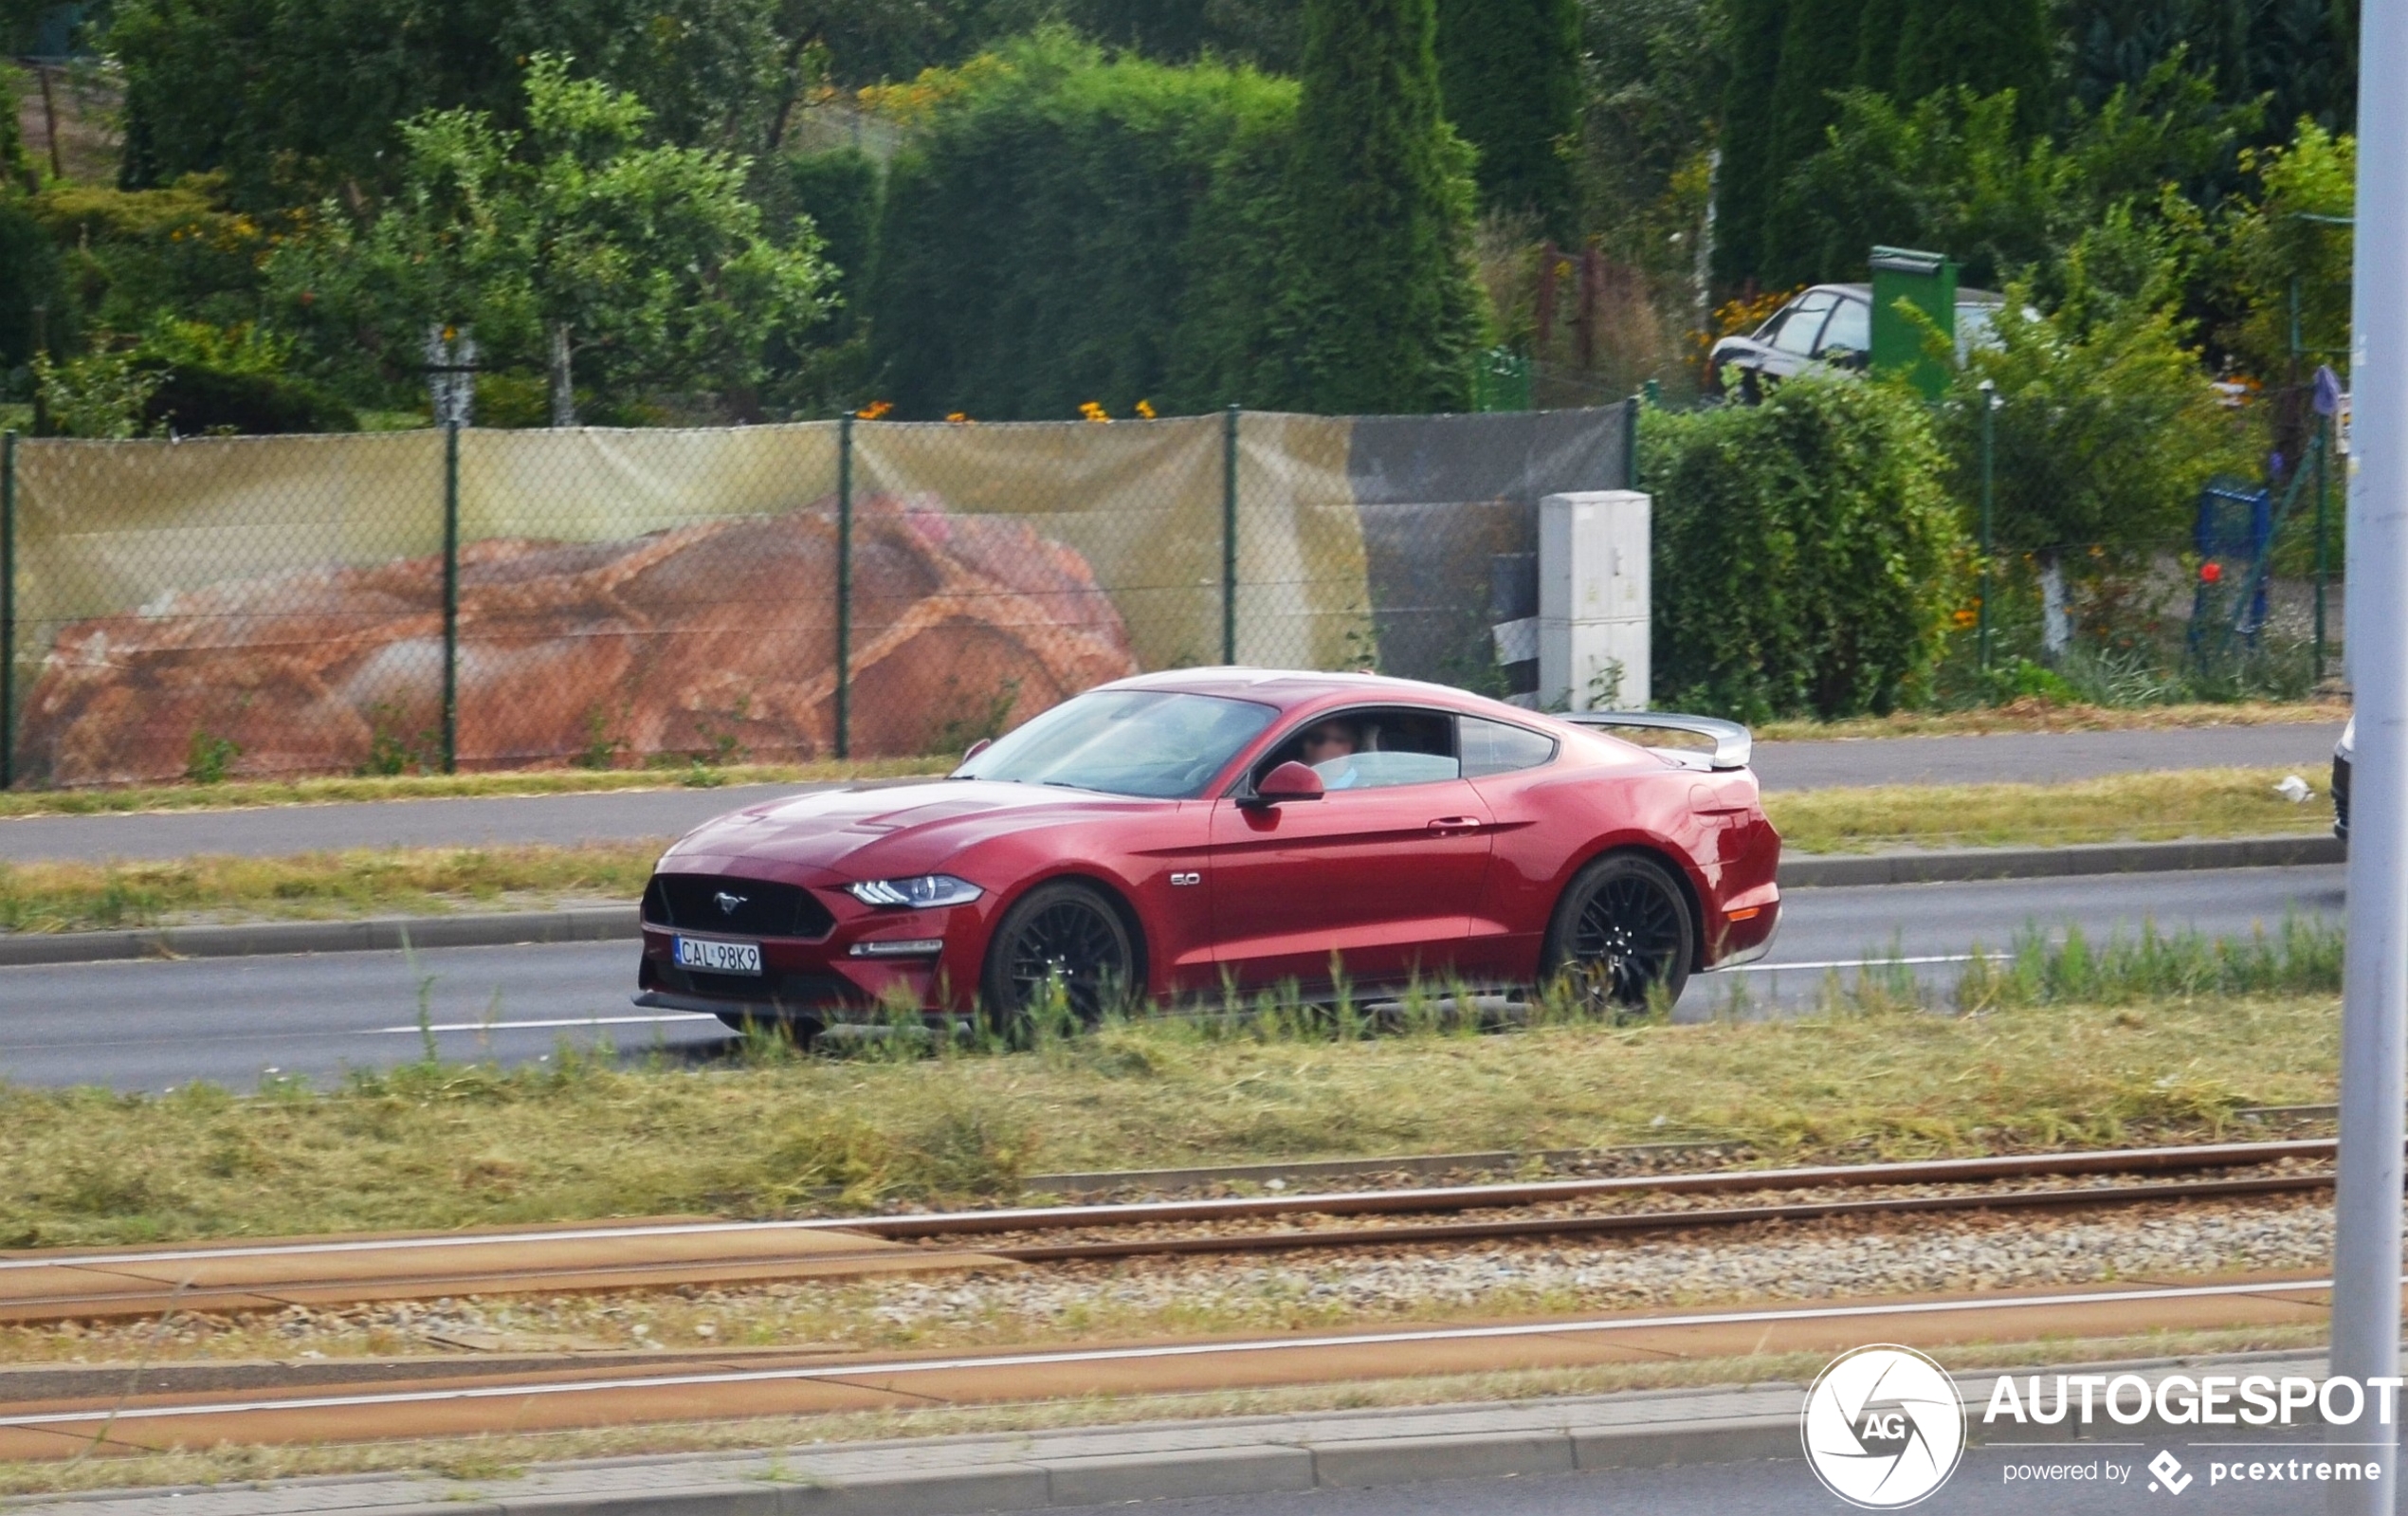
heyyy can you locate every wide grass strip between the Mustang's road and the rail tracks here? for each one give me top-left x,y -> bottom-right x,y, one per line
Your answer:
0,924 -> 2341,1247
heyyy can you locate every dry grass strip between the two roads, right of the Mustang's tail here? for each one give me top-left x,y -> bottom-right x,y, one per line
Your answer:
1765,768 -> 2333,851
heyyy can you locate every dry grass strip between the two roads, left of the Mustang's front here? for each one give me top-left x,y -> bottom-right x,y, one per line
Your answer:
0,837 -> 667,931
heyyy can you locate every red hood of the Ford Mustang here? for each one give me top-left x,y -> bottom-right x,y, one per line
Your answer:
660,779 -> 1177,878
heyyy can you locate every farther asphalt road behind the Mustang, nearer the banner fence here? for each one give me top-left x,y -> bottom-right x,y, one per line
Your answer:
0,724 -> 2341,862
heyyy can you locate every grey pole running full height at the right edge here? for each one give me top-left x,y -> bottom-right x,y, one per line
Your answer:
2326,0 -> 2408,1516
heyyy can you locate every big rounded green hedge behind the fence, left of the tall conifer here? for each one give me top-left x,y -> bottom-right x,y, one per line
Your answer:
865,31 -> 1296,421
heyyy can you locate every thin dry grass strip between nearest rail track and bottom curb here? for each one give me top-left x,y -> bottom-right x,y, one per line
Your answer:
0,1325 -> 2326,1499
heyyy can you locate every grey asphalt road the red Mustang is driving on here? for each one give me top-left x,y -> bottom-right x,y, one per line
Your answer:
0,864 -> 2343,1090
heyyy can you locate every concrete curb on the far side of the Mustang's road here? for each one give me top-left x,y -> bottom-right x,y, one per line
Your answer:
0,837 -> 2348,967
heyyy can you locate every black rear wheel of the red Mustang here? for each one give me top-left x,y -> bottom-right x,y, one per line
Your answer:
1541,851 -> 1698,1015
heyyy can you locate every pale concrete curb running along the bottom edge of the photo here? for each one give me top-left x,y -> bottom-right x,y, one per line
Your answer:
0,1350 -> 2322,1516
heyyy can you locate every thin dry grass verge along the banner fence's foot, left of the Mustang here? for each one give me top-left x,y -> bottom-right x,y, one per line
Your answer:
0,758 -> 960,818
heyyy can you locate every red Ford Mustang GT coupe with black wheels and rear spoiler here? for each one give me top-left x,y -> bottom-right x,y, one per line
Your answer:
636,669 -> 1779,1030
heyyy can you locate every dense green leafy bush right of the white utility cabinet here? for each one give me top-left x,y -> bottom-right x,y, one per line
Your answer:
1640,377 -> 1967,721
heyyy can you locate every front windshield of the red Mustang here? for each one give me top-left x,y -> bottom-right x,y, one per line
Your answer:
954,690 -> 1279,799
